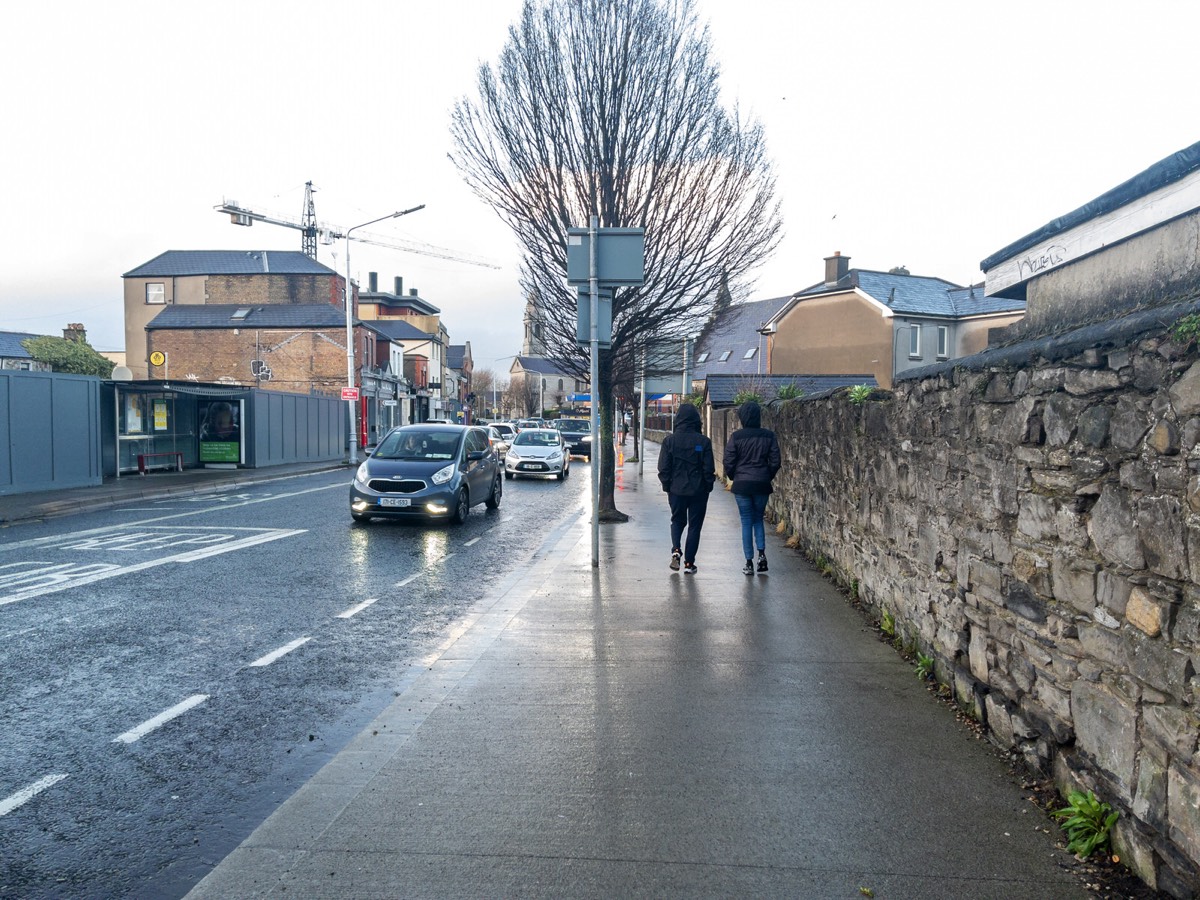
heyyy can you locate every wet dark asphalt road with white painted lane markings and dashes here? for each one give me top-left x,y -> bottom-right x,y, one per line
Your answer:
0,461 -> 590,898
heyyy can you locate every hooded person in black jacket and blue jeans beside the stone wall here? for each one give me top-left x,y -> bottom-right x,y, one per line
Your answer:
721,400 -> 781,575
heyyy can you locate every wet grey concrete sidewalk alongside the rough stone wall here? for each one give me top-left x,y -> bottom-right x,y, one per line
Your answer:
180,446 -> 1087,900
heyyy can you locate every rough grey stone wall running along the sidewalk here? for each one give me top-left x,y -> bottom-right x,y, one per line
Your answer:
709,296 -> 1200,896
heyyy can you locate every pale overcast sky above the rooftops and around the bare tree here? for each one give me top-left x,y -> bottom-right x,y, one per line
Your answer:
0,0 -> 1200,371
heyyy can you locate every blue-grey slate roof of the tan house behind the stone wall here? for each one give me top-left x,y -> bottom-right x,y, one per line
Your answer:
794,269 -> 1025,319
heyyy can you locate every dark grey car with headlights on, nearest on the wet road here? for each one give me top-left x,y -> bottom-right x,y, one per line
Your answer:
350,422 -> 504,522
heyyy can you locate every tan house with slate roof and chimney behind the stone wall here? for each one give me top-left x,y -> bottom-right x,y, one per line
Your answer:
763,253 -> 1025,388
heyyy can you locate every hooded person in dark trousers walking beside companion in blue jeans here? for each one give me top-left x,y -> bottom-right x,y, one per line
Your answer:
659,403 -> 716,575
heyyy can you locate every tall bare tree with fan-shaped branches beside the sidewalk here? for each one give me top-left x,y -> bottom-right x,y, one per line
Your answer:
450,0 -> 781,521
